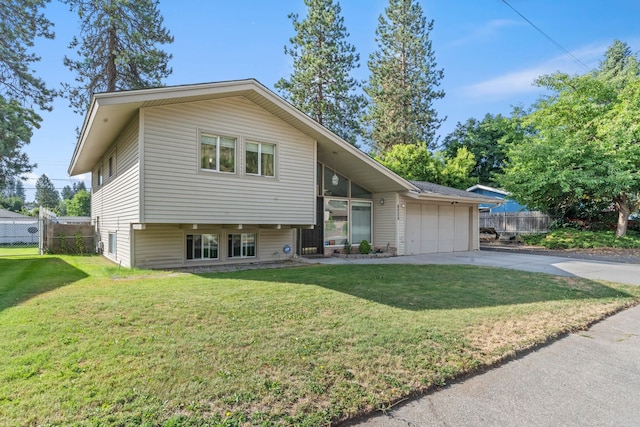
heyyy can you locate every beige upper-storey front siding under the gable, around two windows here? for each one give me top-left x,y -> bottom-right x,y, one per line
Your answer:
143,97 -> 315,224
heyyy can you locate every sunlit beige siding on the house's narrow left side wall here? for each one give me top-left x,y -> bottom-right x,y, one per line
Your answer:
91,117 -> 140,267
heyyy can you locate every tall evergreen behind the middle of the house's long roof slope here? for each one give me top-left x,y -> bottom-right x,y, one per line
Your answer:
275,0 -> 365,145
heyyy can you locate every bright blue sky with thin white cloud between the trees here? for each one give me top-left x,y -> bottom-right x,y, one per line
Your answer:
25,0 -> 640,200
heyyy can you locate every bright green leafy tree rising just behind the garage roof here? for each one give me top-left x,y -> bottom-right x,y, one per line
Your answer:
375,144 -> 476,189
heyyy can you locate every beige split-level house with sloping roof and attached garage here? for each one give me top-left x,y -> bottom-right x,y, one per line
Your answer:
69,79 -> 491,268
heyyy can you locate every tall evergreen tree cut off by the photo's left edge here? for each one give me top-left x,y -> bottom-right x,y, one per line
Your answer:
0,0 -> 54,190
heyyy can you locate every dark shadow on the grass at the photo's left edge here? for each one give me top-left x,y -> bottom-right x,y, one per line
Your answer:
0,257 -> 87,311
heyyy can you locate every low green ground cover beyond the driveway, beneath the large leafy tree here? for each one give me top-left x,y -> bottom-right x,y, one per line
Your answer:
520,228 -> 640,249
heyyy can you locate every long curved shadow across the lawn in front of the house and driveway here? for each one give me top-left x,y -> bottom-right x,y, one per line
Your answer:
203,265 -> 632,311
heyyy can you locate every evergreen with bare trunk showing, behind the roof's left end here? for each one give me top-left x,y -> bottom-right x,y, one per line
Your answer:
63,0 -> 173,114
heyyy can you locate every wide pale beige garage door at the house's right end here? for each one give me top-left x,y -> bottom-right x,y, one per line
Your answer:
405,203 -> 470,255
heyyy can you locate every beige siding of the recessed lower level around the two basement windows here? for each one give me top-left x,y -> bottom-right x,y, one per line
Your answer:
134,224 -> 295,268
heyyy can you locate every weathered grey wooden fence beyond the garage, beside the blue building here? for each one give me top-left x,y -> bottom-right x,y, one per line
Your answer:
480,212 -> 552,234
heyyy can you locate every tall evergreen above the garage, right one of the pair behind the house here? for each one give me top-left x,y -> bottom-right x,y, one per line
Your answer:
364,0 -> 444,152
